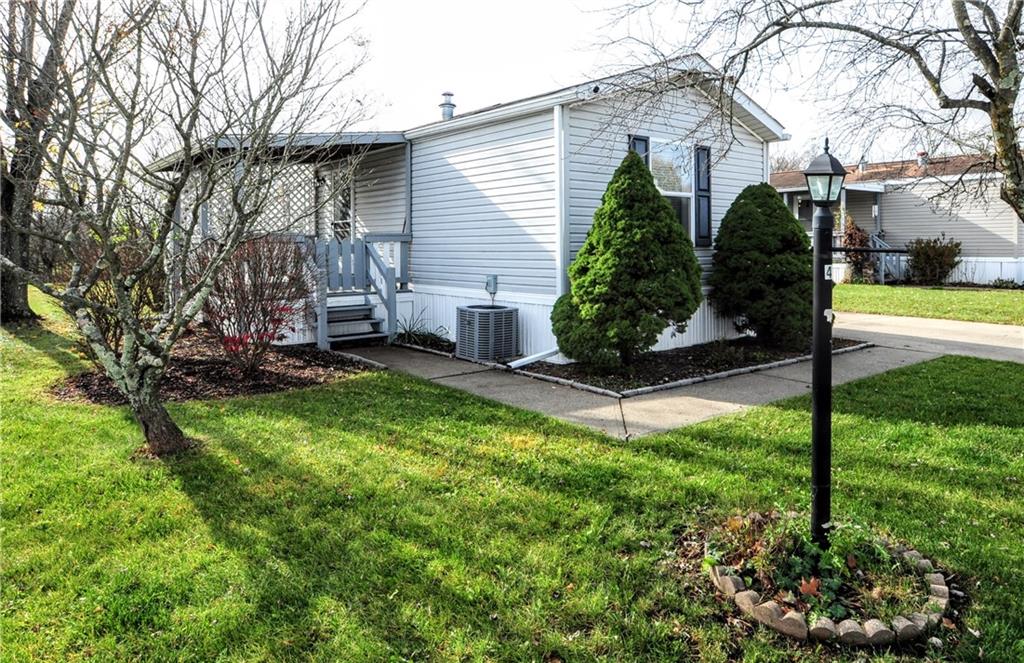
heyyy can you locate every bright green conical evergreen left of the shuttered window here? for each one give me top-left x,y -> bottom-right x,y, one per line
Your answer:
551,152 -> 700,366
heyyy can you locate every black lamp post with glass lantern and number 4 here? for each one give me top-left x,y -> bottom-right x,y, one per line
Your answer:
804,138 -> 846,548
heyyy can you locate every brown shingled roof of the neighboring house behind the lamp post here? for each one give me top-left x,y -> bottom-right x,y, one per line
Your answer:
770,155 -> 995,191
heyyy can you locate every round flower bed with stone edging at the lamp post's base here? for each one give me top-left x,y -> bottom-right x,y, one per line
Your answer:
706,512 -> 958,647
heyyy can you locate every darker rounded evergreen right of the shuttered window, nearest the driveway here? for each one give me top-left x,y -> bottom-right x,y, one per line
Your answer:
711,183 -> 813,348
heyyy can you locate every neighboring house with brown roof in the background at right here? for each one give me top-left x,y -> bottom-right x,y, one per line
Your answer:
771,153 -> 1024,283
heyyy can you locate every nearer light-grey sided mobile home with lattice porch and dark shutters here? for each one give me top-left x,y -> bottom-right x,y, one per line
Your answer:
172,57 -> 787,356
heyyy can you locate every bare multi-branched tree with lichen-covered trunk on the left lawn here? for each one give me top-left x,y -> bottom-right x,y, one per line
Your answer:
0,0 -> 365,455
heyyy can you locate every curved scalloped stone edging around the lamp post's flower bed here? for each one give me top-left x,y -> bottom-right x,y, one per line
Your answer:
709,539 -> 949,647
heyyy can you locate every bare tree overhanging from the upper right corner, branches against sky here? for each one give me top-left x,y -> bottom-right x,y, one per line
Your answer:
617,0 -> 1024,222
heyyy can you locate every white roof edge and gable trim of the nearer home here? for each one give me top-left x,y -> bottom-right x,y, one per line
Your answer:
406,54 -> 790,141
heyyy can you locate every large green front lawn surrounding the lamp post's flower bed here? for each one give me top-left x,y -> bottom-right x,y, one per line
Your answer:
0,299 -> 1024,661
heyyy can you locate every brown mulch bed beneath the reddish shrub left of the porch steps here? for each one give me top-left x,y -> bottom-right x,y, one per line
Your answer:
51,330 -> 371,405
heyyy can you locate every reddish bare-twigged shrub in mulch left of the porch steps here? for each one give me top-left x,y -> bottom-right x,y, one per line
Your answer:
189,237 -> 314,375
